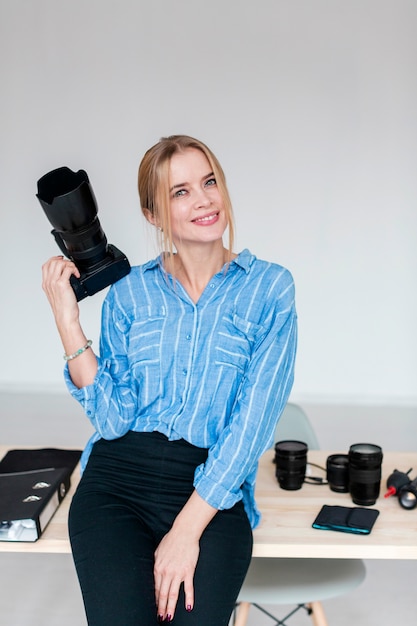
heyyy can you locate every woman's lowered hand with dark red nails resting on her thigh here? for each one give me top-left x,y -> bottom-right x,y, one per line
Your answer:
154,527 -> 200,622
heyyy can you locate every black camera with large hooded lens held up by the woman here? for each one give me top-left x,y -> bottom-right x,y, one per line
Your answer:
36,167 -> 130,301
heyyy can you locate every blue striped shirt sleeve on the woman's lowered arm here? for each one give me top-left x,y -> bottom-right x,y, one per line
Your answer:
194,286 -> 297,523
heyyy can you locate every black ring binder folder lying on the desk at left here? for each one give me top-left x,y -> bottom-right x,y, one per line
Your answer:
0,448 -> 81,542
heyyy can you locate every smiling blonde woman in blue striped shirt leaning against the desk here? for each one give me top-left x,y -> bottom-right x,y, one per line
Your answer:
43,135 -> 296,626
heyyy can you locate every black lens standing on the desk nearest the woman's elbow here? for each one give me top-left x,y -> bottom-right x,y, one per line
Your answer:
275,439 -> 308,491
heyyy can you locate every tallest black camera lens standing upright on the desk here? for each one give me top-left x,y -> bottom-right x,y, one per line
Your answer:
349,443 -> 382,506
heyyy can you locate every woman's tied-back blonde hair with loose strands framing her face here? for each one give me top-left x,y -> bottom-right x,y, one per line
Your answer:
138,135 -> 234,261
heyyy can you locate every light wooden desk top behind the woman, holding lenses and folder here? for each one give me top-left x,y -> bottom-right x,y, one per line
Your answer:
0,446 -> 417,559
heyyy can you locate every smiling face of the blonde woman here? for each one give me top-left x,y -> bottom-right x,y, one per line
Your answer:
169,148 -> 227,247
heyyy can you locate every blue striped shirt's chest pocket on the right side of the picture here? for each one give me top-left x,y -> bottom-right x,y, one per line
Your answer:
215,313 -> 263,372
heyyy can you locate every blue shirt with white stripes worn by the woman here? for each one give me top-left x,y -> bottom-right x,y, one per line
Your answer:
66,250 -> 297,527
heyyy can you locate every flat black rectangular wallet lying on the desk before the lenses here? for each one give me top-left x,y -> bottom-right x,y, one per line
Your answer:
313,504 -> 379,535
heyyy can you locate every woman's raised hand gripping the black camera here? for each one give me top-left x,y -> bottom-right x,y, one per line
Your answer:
42,256 -> 80,327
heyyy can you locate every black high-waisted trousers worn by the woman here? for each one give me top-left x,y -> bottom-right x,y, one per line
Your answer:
69,432 -> 252,626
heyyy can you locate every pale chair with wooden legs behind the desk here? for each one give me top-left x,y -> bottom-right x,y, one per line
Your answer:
233,403 -> 366,626
